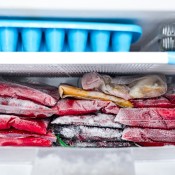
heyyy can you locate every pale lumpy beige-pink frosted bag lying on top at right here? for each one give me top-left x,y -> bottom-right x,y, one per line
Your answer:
82,73 -> 167,100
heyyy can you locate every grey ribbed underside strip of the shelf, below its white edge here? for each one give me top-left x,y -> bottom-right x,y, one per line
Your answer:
0,64 -> 175,76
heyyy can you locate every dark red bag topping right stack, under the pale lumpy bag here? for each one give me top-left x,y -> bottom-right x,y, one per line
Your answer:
130,97 -> 175,108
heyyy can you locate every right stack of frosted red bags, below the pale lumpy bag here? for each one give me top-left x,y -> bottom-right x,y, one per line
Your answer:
115,84 -> 175,146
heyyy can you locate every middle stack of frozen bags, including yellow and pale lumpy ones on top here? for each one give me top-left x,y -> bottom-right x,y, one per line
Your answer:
52,72 -> 167,147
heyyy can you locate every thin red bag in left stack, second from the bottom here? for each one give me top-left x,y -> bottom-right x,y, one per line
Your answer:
0,128 -> 56,142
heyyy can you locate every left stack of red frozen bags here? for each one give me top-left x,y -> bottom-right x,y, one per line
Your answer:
0,80 -> 59,147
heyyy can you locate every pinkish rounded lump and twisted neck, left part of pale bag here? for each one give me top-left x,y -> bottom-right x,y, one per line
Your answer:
81,72 -> 131,100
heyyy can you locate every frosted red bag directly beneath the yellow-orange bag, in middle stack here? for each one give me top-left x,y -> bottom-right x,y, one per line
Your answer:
52,99 -> 119,116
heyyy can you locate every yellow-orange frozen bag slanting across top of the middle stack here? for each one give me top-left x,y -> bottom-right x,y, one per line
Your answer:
59,85 -> 133,107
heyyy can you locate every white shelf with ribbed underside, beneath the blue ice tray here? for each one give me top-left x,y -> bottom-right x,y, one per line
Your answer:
0,52 -> 175,76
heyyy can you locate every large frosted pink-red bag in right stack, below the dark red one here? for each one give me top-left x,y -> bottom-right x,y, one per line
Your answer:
115,108 -> 175,129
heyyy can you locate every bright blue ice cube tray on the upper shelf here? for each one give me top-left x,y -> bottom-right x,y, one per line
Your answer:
0,19 -> 142,52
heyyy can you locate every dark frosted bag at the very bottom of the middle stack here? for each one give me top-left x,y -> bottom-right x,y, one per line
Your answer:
61,140 -> 135,148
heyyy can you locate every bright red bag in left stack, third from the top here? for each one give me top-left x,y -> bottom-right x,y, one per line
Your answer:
0,114 -> 49,134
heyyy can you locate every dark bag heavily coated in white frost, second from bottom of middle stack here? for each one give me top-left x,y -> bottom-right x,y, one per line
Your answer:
54,125 -> 122,141
